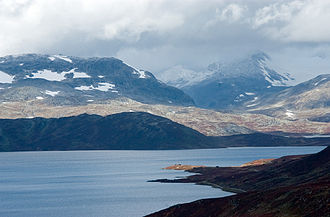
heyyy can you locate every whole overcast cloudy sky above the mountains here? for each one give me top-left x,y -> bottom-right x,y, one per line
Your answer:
0,0 -> 330,81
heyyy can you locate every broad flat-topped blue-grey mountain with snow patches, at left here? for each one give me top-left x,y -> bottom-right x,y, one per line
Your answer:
0,54 -> 194,105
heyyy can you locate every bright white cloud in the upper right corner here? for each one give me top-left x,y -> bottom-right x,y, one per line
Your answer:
253,0 -> 330,43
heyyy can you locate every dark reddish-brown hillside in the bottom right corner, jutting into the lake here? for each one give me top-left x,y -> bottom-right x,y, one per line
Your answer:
149,147 -> 330,217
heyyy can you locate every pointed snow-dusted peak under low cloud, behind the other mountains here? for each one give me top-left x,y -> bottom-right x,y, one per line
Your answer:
163,52 -> 293,109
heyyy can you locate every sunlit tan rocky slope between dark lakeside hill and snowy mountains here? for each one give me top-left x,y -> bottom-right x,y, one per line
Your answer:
0,98 -> 330,136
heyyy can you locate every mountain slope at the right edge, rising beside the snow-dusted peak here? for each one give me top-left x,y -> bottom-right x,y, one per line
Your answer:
251,74 -> 330,118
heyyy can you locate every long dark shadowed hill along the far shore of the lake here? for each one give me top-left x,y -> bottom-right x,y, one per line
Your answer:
0,112 -> 330,151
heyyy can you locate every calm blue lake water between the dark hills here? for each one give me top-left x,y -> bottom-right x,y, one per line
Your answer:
0,147 -> 324,217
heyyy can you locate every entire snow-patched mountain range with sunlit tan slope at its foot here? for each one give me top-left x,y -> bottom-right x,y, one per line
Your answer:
0,52 -> 330,142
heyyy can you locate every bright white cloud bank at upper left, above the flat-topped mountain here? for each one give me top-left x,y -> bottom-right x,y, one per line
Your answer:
0,0 -> 184,54
